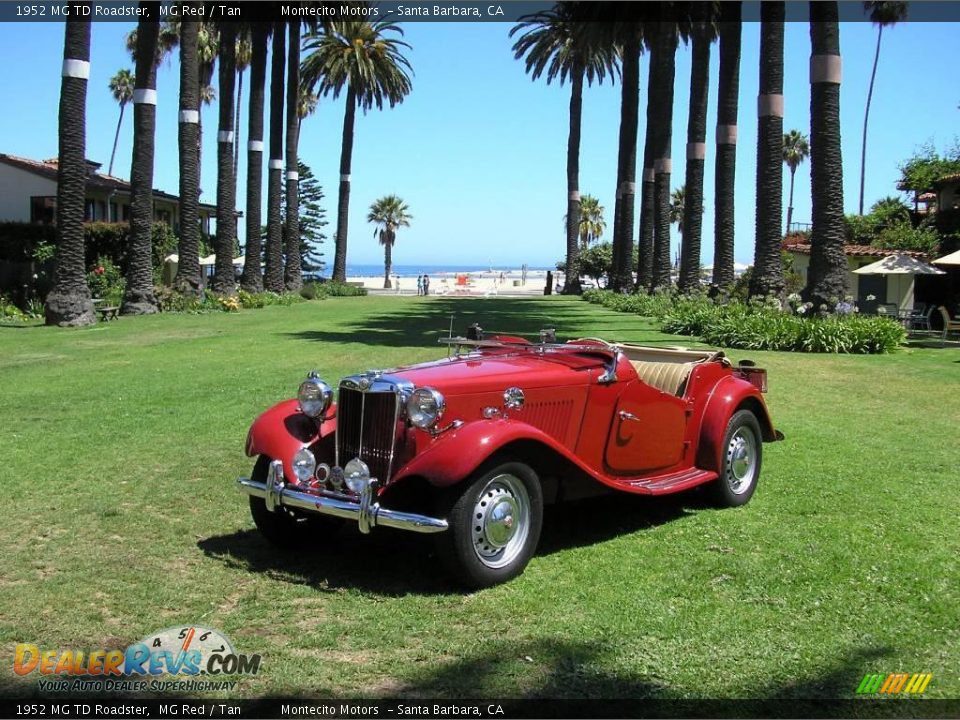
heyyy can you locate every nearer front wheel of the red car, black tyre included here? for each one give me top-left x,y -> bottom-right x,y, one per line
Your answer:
436,462 -> 543,588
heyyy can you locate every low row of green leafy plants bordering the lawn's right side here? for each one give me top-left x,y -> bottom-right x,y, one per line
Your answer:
584,290 -> 906,354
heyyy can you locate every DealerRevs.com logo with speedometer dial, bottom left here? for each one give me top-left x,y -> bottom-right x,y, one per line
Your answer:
13,625 -> 261,692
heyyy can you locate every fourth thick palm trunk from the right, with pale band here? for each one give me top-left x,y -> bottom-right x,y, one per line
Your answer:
678,11 -> 710,292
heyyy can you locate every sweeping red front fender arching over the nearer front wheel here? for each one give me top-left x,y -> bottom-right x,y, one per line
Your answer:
394,418 -> 612,487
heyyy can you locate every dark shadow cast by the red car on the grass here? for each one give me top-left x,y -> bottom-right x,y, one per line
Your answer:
197,494 -> 690,596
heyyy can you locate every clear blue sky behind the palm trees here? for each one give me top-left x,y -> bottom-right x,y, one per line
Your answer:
0,16 -> 960,266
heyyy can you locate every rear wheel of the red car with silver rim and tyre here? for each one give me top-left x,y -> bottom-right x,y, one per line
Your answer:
712,410 -> 763,507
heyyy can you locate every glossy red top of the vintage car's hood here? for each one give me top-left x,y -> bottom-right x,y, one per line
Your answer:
387,350 -> 604,394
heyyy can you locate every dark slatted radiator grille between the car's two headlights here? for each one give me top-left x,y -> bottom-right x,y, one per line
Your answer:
337,385 -> 397,484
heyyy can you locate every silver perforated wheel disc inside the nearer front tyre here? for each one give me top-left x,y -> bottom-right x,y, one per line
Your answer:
472,474 -> 530,568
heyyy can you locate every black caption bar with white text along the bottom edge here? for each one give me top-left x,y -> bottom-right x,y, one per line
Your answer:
0,697 -> 960,720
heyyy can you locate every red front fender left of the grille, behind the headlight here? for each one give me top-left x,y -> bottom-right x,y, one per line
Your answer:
246,400 -> 337,478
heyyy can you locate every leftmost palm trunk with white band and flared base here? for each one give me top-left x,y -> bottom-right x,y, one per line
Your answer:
44,13 -> 97,326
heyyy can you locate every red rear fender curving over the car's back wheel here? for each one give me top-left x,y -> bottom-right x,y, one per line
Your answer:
697,375 -> 777,472
